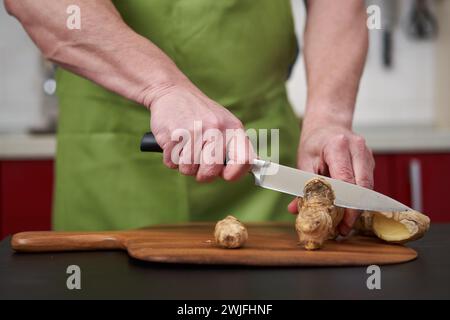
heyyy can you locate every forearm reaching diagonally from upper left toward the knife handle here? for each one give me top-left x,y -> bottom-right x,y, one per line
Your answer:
5,0 -> 188,107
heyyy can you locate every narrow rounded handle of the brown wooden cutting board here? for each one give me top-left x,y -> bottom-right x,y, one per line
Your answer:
11,231 -> 125,252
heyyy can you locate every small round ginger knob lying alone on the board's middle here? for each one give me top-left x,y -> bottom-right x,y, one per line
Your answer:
214,216 -> 248,249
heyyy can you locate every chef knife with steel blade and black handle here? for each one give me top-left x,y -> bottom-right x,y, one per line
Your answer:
141,132 -> 412,211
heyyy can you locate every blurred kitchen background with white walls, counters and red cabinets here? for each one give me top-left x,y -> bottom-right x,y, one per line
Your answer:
0,0 -> 450,238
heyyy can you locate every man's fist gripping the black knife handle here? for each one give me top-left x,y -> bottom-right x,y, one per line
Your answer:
150,81 -> 254,182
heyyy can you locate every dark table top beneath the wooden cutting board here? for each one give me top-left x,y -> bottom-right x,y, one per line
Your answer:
0,224 -> 450,299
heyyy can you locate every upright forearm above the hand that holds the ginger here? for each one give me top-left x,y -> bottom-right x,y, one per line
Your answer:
304,0 -> 368,128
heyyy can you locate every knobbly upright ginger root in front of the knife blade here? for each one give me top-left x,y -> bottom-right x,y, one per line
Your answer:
295,178 -> 344,250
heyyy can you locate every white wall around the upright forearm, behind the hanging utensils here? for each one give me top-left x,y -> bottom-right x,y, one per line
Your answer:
288,0 -> 436,127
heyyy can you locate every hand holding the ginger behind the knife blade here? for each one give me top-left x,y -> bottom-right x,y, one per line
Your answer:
288,123 -> 375,235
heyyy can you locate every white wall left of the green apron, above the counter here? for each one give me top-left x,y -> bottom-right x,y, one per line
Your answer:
0,1 -> 42,132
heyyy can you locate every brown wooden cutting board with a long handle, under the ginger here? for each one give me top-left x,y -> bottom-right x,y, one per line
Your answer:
11,223 -> 417,266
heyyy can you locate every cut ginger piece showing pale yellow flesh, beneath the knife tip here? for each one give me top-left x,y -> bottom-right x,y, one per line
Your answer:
355,211 -> 430,243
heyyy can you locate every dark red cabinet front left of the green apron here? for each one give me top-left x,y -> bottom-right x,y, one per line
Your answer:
0,160 -> 53,238
